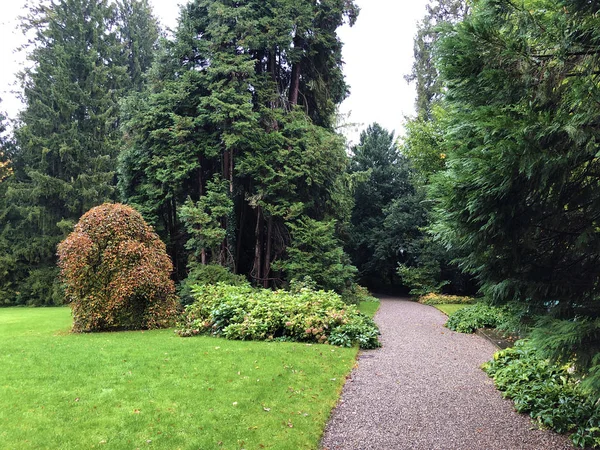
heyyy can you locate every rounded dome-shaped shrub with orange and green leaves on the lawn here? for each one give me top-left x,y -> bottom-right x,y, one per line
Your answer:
58,203 -> 179,332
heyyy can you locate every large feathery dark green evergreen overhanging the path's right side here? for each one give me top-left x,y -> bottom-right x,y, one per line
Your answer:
434,0 -> 600,392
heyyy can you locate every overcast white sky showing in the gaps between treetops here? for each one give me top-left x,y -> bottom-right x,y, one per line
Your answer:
0,0 -> 427,141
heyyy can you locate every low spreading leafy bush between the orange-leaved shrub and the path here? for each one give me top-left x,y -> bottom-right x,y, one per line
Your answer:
177,283 -> 379,348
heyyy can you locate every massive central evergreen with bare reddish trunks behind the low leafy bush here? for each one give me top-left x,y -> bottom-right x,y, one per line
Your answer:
120,0 -> 358,286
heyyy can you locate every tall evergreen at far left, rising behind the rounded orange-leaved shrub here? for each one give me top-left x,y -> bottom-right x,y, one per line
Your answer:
0,0 -> 156,304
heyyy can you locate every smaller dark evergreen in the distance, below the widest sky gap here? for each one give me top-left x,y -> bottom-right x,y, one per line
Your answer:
348,123 -> 424,284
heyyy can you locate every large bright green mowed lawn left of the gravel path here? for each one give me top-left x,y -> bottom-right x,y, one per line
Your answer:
0,308 -> 357,449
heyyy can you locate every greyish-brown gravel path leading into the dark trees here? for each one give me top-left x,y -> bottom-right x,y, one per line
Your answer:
322,298 -> 572,450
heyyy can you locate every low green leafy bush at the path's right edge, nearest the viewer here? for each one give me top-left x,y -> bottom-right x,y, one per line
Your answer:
483,341 -> 600,447
